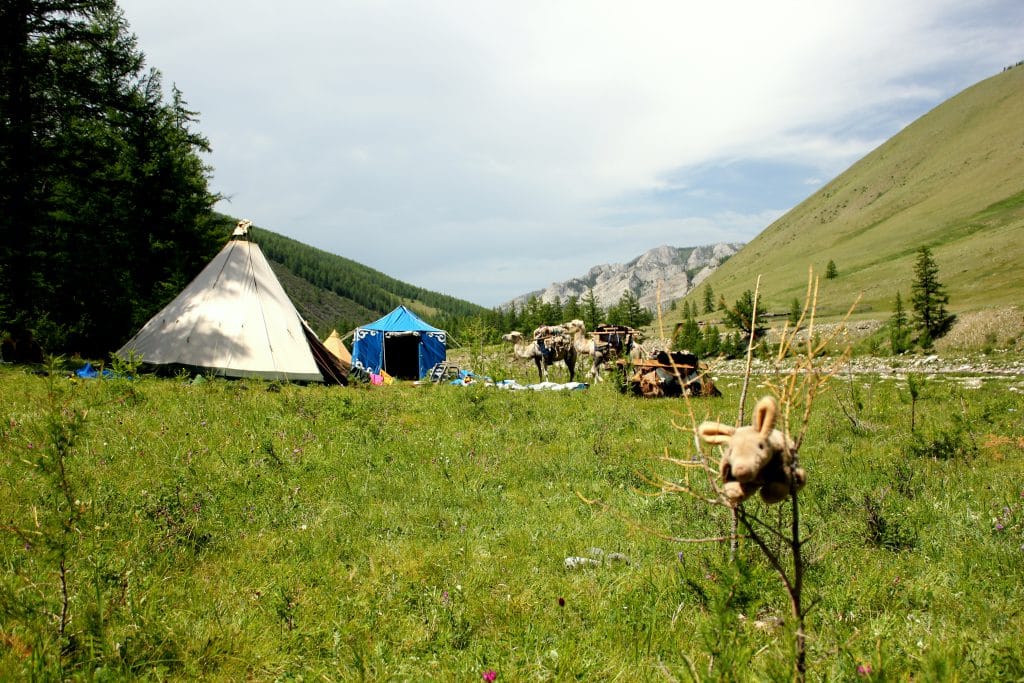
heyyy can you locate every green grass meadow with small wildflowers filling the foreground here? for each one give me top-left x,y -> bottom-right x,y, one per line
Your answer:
0,366 -> 1024,681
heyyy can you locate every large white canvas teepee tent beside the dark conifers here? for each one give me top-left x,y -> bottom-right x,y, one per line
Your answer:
117,221 -> 345,383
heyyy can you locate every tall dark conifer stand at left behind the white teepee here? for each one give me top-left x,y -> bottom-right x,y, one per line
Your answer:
0,0 -> 222,357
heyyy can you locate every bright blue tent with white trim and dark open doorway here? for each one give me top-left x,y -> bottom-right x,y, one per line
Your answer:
352,306 -> 447,380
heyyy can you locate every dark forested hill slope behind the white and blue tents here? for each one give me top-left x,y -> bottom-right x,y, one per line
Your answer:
230,219 -> 484,337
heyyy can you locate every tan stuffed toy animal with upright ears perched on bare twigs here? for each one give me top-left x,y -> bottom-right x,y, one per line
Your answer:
697,396 -> 807,506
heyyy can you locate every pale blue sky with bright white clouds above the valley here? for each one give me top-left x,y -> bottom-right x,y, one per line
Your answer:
121,0 -> 1024,306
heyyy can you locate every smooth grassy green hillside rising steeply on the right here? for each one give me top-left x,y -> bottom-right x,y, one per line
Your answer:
679,68 -> 1024,322
